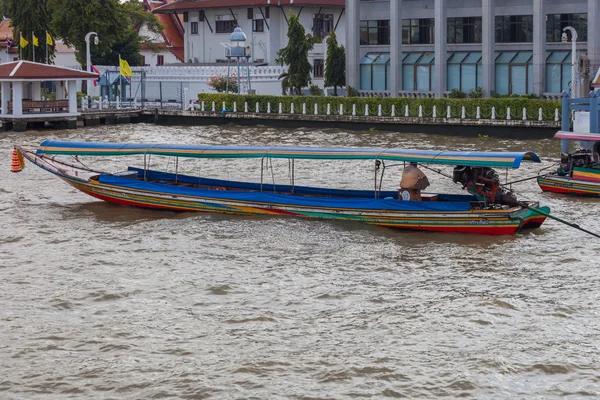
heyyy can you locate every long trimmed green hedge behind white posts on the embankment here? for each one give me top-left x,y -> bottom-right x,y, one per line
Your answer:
198,93 -> 561,121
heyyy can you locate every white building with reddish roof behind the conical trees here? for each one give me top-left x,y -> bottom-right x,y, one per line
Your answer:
153,0 -> 345,86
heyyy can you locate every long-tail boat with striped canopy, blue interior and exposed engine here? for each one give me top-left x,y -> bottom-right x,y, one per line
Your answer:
15,140 -> 550,235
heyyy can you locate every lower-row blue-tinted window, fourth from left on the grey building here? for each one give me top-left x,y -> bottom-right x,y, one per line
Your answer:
495,51 -> 533,94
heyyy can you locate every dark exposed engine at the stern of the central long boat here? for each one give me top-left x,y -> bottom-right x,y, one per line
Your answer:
452,165 -> 518,206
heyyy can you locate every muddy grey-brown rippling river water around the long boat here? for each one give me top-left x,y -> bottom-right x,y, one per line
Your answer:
0,124 -> 600,399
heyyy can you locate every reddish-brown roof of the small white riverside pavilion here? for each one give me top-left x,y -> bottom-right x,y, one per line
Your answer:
0,61 -> 98,81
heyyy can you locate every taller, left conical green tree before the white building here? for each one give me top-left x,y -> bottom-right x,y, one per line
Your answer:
275,11 -> 315,95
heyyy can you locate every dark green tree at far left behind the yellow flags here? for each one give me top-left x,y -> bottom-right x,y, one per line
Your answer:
8,0 -> 54,63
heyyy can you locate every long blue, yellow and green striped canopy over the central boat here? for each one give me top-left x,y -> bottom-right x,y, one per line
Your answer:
36,140 -> 540,168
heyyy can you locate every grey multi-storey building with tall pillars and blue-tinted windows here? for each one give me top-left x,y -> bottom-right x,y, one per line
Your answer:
346,0 -> 600,97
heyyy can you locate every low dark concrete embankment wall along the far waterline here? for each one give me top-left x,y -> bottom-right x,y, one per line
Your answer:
2,108 -> 560,139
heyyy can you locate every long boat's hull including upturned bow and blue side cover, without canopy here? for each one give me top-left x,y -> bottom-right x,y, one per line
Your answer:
22,152 -> 549,235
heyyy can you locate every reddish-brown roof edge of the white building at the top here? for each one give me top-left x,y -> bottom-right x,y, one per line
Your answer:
152,0 -> 346,14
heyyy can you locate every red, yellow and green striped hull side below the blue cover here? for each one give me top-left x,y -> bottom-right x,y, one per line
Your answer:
63,178 -> 549,235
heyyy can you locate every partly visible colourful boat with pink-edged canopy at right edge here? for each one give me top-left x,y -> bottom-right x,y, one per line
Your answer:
537,131 -> 600,197
